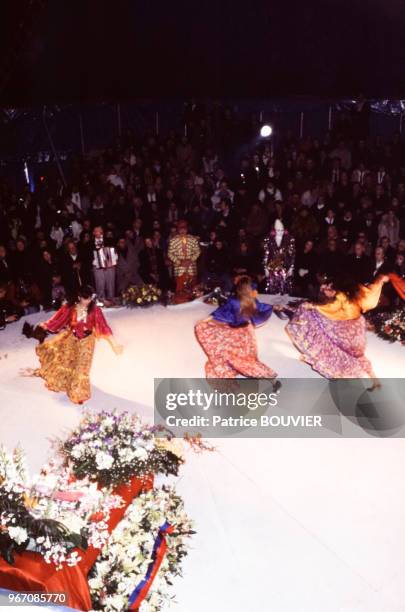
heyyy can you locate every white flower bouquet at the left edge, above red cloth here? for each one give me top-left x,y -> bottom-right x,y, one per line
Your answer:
0,448 -> 123,569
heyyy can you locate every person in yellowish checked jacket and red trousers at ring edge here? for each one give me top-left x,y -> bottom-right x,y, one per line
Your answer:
168,220 -> 201,304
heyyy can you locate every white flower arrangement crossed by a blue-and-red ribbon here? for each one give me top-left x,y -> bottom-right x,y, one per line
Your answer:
89,487 -> 195,612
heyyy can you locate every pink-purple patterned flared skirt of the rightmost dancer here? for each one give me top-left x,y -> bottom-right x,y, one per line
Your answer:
286,304 -> 373,378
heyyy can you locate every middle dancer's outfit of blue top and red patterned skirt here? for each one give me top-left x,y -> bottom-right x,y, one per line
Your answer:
195,297 -> 277,378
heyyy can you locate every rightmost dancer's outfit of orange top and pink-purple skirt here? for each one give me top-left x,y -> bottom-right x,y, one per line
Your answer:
286,279 -> 383,378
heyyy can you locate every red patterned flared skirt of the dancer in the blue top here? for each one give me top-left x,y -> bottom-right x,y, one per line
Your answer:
195,320 -> 277,378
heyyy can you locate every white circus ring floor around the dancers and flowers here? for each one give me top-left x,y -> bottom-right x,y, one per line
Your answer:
0,296 -> 405,612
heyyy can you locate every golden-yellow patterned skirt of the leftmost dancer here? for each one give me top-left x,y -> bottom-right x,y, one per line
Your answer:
35,331 -> 95,404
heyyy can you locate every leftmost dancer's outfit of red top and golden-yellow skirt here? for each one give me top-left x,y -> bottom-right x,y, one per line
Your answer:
35,305 -> 112,404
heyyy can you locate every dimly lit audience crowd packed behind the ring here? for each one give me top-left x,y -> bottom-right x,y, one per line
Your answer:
0,105 -> 405,327
